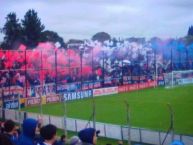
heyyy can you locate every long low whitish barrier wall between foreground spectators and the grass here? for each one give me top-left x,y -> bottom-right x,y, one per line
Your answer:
0,109 -> 193,145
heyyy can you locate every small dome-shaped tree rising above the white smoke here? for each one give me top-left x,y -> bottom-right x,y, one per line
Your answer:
92,32 -> 111,43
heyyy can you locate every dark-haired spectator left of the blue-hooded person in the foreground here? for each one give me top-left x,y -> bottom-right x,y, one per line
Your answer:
4,120 -> 18,144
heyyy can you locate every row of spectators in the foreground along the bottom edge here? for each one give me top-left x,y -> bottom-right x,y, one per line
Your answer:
0,118 -> 123,145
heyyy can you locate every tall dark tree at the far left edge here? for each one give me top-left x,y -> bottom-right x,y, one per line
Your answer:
1,13 -> 21,49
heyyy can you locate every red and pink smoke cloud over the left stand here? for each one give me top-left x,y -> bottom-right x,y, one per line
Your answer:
0,42 -> 93,81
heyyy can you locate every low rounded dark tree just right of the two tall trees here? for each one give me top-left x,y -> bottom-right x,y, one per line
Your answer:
40,30 -> 66,48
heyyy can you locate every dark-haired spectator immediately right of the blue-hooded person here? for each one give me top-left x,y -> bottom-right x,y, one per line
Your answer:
39,124 -> 57,145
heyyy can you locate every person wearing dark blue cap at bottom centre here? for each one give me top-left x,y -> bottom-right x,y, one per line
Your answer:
78,128 -> 99,145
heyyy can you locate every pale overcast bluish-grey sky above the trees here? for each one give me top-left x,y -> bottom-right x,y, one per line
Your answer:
0,0 -> 193,41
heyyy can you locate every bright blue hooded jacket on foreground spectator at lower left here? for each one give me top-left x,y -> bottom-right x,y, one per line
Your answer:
18,118 -> 38,145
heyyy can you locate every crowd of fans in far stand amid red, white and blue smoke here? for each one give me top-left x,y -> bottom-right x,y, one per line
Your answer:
0,40 -> 193,93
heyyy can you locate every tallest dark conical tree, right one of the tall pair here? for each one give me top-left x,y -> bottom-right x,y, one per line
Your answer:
22,9 -> 45,47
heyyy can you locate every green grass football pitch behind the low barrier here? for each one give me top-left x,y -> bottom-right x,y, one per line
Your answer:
24,85 -> 193,135
